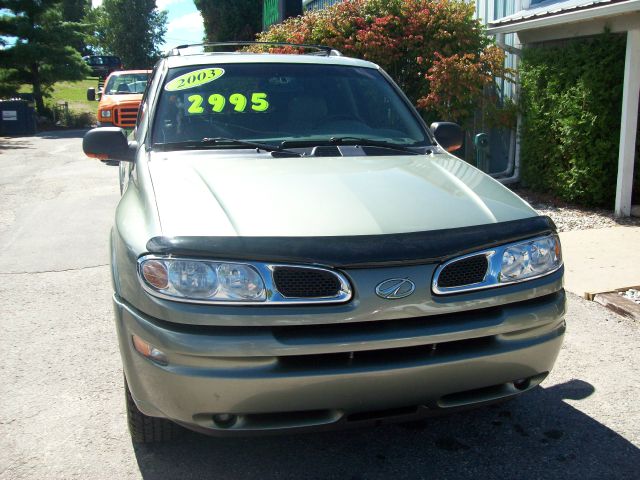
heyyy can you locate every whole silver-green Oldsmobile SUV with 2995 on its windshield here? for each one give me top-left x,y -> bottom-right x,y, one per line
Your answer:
83,46 -> 565,442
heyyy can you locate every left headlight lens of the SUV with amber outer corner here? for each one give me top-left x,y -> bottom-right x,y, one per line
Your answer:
138,257 -> 266,302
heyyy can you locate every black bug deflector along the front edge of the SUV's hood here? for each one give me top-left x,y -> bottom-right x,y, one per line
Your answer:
147,216 -> 556,268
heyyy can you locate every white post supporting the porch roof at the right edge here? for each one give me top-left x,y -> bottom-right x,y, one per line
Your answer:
615,28 -> 640,217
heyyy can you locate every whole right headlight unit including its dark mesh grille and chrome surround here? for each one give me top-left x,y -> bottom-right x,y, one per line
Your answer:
432,235 -> 562,295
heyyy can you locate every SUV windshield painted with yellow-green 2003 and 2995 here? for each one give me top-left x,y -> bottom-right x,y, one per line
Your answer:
152,63 -> 430,146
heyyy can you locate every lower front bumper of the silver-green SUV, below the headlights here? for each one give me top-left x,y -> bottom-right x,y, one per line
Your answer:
114,290 -> 566,434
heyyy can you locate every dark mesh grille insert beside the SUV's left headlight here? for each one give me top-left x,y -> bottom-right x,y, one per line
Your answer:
273,267 -> 341,298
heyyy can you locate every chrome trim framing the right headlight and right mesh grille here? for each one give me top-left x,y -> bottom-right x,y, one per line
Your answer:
431,234 -> 564,295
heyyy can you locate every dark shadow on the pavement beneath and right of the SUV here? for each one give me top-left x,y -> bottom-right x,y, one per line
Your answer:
135,380 -> 640,480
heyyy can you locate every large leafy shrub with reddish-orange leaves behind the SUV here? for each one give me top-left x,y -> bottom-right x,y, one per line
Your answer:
258,0 -> 512,127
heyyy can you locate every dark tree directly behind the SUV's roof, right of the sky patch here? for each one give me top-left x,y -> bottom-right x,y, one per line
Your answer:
194,0 -> 262,42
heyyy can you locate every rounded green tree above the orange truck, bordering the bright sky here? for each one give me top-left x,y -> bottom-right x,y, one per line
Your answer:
90,0 -> 167,69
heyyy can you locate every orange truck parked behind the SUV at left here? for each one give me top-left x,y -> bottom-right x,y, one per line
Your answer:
87,70 -> 151,129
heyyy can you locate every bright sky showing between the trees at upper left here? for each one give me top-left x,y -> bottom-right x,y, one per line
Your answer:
92,0 -> 204,52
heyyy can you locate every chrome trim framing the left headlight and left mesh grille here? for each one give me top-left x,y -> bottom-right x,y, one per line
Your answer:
136,254 -> 353,307
